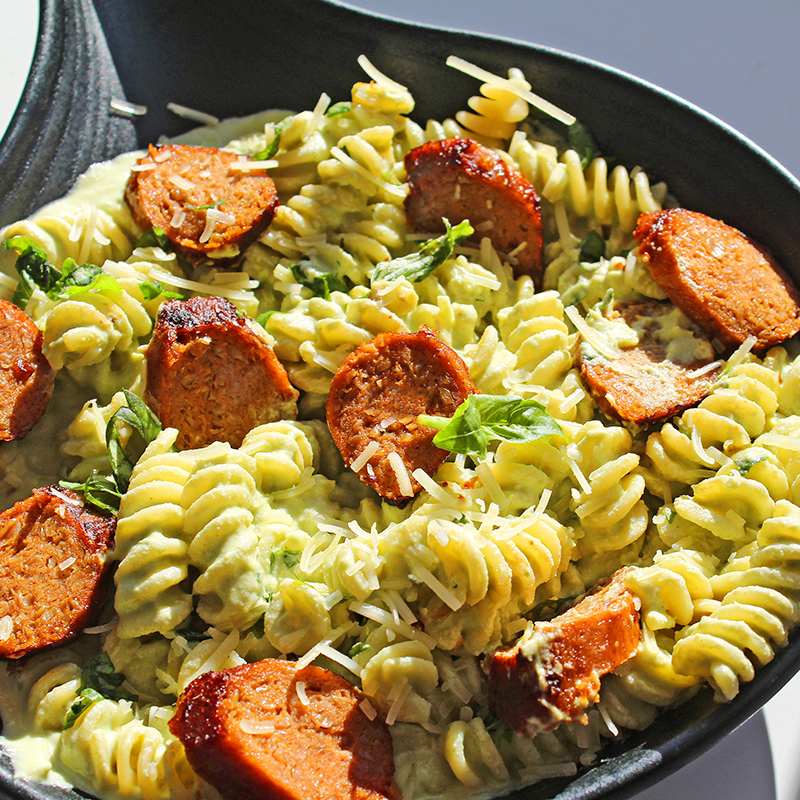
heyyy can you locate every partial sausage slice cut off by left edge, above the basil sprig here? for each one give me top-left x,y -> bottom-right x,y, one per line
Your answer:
0,300 -> 55,442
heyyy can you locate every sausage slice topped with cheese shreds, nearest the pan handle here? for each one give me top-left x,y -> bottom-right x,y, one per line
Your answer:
125,144 -> 278,264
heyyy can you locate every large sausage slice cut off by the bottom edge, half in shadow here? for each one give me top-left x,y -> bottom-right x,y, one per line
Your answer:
169,659 -> 399,800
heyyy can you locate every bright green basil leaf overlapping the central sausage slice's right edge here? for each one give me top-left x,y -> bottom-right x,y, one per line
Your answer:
417,394 -> 566,460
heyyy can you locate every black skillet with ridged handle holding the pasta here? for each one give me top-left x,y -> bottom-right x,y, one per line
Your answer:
0,0 -> 800,800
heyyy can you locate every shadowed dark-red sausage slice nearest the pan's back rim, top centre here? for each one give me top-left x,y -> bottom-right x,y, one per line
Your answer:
405,139 -> 542,287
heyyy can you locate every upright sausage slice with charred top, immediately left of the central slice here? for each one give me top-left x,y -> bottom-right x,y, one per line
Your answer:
145,297 -> 299,450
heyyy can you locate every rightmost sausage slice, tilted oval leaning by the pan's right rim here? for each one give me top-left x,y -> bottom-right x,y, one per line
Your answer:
634,208 -> 800,352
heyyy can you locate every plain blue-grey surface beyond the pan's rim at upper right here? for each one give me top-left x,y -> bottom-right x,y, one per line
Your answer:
347,0 -> 800,181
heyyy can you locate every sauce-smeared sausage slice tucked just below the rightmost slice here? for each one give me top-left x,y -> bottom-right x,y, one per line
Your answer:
578,300 -> 719,426
